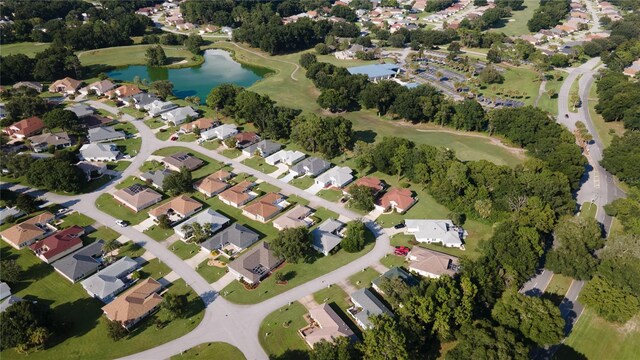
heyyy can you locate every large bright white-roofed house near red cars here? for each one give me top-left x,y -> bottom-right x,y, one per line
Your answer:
404,219 -> 466,249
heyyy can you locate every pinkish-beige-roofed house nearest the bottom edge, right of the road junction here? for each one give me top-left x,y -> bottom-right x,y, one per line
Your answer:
298,304 -> 355,349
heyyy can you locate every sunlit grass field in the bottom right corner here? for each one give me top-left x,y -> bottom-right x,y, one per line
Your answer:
554,308 -> 640,360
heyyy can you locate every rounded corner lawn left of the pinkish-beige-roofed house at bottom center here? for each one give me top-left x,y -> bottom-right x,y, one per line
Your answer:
258,301 -> 308,360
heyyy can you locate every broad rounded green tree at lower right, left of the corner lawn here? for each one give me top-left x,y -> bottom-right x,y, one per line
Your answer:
491,291 -> 565,347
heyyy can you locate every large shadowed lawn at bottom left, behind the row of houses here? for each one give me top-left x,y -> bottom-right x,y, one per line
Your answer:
0,242 -> 204,360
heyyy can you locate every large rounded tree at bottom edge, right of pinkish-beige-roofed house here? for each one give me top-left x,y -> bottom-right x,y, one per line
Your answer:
356,315 -> 409,360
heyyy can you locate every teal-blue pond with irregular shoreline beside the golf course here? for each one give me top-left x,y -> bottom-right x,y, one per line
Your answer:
108,49 -> 271,103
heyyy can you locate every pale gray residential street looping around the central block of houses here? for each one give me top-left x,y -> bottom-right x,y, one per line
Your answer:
7,101 -> 392,360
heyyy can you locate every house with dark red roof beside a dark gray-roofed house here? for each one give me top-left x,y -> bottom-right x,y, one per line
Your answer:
29,225 -> 84,264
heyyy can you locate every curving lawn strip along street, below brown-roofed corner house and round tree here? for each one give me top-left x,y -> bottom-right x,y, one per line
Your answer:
223,225 -> 375,304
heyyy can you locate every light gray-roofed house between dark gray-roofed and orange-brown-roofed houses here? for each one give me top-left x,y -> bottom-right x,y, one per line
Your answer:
81,256 -> 140,304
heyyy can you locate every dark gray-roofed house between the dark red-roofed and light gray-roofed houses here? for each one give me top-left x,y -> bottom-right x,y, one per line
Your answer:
52,240 -> 104,283
